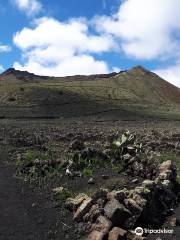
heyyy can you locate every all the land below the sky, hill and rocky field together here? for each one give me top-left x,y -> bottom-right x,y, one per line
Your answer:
0,67 -> 180,240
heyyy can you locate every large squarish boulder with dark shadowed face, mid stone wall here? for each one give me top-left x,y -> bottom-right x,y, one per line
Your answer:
104,199 -> 131,226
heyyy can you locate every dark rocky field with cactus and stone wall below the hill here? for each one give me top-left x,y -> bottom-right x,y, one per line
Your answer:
1,120 -> 180,240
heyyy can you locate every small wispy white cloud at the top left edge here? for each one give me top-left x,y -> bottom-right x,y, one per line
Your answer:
13,0 -> 42,16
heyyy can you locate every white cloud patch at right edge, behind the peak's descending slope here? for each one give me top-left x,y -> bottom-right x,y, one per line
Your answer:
153,63 -> 180,87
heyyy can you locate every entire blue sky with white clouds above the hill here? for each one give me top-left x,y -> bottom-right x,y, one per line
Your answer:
0,0 -> 180,87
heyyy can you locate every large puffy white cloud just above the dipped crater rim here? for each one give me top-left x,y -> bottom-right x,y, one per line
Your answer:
13,18 -> 116,76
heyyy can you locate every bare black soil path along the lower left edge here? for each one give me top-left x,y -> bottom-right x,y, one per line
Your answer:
0,149 -> 57,240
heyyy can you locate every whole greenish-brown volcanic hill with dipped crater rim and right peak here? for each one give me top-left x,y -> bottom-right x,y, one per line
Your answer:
0,66 -> 180,120
